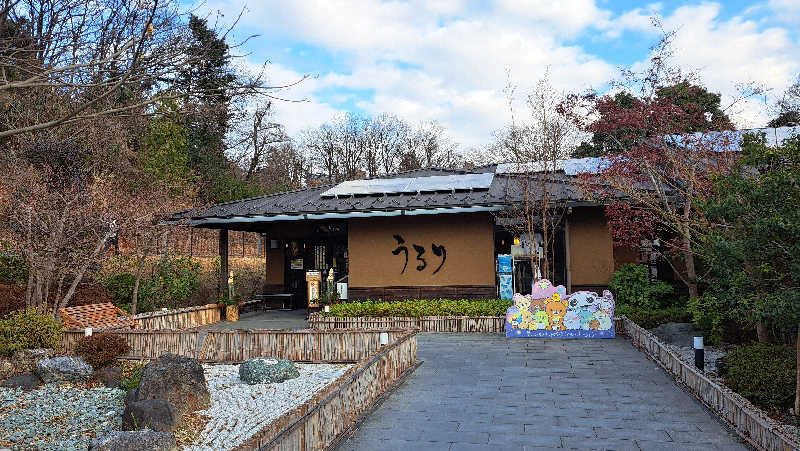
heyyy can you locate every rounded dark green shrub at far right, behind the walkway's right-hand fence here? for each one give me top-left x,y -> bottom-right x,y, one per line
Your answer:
725,343 -> 797,409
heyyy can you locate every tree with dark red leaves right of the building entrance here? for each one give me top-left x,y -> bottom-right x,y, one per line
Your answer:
565,25 -> 738,298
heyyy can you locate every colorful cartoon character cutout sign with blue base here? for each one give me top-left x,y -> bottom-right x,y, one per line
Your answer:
506,279 -> 615,338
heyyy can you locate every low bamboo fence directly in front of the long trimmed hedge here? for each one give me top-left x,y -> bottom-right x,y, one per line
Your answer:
308,312 -> 506,334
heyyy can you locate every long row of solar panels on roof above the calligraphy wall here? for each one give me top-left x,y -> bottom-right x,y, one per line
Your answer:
322,173 -> 494,197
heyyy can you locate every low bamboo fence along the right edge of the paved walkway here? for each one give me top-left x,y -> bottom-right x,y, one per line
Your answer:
617,316 -> 800,451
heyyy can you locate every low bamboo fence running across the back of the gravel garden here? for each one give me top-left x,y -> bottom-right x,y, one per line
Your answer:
62,329 -> 409,362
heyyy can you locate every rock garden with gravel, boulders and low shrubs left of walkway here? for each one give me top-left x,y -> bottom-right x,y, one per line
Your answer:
0,312 -> 352,451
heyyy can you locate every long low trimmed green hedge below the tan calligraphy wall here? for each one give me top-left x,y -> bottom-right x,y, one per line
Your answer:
324,299 -> 512,317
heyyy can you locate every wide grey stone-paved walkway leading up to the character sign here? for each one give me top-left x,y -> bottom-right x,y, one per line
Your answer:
338,334 -> 748,451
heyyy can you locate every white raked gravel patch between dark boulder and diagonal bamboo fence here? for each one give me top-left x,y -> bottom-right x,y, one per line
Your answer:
188,363 -> 352,451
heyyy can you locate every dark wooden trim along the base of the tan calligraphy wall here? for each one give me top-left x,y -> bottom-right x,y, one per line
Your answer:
347,285 -> 497,301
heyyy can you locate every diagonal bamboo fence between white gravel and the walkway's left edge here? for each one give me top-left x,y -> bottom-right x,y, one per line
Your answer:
236,331 -> 417,451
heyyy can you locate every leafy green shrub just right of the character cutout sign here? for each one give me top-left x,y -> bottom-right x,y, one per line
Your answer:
608,263 -> 675,309
